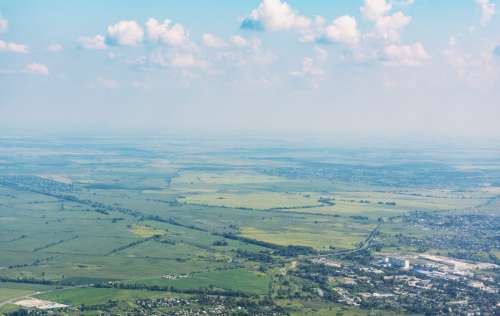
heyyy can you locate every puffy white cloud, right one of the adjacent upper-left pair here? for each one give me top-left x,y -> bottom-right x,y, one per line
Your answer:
146,18 -> 191,46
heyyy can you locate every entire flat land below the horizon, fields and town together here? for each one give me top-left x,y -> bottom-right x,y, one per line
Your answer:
0,138 -> 500,315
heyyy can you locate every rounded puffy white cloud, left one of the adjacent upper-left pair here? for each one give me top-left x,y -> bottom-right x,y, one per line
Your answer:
106,21 -> 144,46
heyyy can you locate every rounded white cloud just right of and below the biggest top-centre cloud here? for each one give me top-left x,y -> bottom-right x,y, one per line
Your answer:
324,15 -> 360,46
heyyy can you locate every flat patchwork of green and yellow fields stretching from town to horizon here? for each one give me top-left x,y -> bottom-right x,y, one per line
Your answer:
0,140 -> 500,315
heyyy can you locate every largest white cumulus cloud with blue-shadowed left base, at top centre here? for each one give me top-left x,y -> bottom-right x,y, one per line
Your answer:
241,0 -> 311,31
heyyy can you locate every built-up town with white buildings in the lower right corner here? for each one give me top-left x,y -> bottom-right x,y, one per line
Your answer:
291,254 -> 500,314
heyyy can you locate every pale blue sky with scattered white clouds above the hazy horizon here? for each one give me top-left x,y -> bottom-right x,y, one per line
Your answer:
0,0 -> 500,139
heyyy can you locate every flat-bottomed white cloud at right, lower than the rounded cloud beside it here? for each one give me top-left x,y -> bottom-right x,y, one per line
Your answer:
383,42 -> 431,66
